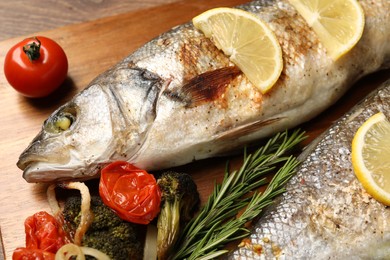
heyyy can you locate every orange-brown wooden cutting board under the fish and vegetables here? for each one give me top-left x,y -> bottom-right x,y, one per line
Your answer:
0,0 -> 389,259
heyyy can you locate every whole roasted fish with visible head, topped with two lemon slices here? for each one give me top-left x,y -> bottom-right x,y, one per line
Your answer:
17,0 -> 390,182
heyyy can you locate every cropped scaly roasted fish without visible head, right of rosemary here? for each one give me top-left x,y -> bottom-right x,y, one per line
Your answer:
231,80 -> 390,259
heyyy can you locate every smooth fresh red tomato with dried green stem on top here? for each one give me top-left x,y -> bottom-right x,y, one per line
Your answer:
4,36 -> 68,98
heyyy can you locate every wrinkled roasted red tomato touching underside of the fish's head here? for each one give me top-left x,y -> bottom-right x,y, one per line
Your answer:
99,161 -> 161,225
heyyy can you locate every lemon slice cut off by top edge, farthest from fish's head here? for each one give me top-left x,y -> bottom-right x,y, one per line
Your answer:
289,0 -> 364,60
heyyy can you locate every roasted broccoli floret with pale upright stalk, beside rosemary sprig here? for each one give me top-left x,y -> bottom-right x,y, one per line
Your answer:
157,171 -> 200,259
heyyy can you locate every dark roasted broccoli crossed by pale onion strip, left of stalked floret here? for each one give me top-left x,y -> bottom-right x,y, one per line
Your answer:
63,192 -> 143,259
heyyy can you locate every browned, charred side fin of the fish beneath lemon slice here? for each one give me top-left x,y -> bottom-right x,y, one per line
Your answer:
168,66 -> 242,107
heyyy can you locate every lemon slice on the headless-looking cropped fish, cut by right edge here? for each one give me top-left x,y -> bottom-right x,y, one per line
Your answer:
352,112 -> 390,205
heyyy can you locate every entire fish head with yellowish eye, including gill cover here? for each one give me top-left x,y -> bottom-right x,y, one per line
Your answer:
17,67 -> 161,182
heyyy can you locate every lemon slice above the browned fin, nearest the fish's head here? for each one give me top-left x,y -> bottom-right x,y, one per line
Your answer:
192,8 -> 283,93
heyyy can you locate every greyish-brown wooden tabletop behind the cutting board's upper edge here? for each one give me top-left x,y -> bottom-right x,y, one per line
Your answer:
0,0 -> 180,40
